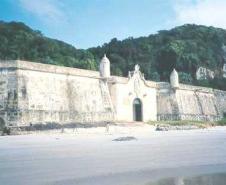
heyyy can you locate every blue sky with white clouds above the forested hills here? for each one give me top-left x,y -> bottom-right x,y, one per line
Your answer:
0,0 -> 226,48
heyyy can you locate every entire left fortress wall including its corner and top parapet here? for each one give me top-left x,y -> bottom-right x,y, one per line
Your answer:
0,61 -> 114,126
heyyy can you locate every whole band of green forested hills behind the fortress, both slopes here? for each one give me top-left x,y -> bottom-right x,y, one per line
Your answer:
0,22 -> 226,90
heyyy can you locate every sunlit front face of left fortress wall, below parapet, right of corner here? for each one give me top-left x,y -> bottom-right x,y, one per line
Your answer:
18,70 -> 113,124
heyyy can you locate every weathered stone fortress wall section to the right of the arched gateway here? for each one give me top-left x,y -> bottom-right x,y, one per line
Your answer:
157,84 -> 222,121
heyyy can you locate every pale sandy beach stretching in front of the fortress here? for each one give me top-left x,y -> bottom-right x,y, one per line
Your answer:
0,126 -> 226,185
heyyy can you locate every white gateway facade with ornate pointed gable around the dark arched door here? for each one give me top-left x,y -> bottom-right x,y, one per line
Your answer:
109,64 -> 157,122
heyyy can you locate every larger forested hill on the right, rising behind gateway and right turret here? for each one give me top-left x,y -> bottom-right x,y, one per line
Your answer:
90,25 -> 226,88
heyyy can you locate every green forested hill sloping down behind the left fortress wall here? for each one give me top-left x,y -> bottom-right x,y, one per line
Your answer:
0,22 -> 97,70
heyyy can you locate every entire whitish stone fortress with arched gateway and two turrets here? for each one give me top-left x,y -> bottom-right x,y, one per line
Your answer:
0,56 -> 226,127
